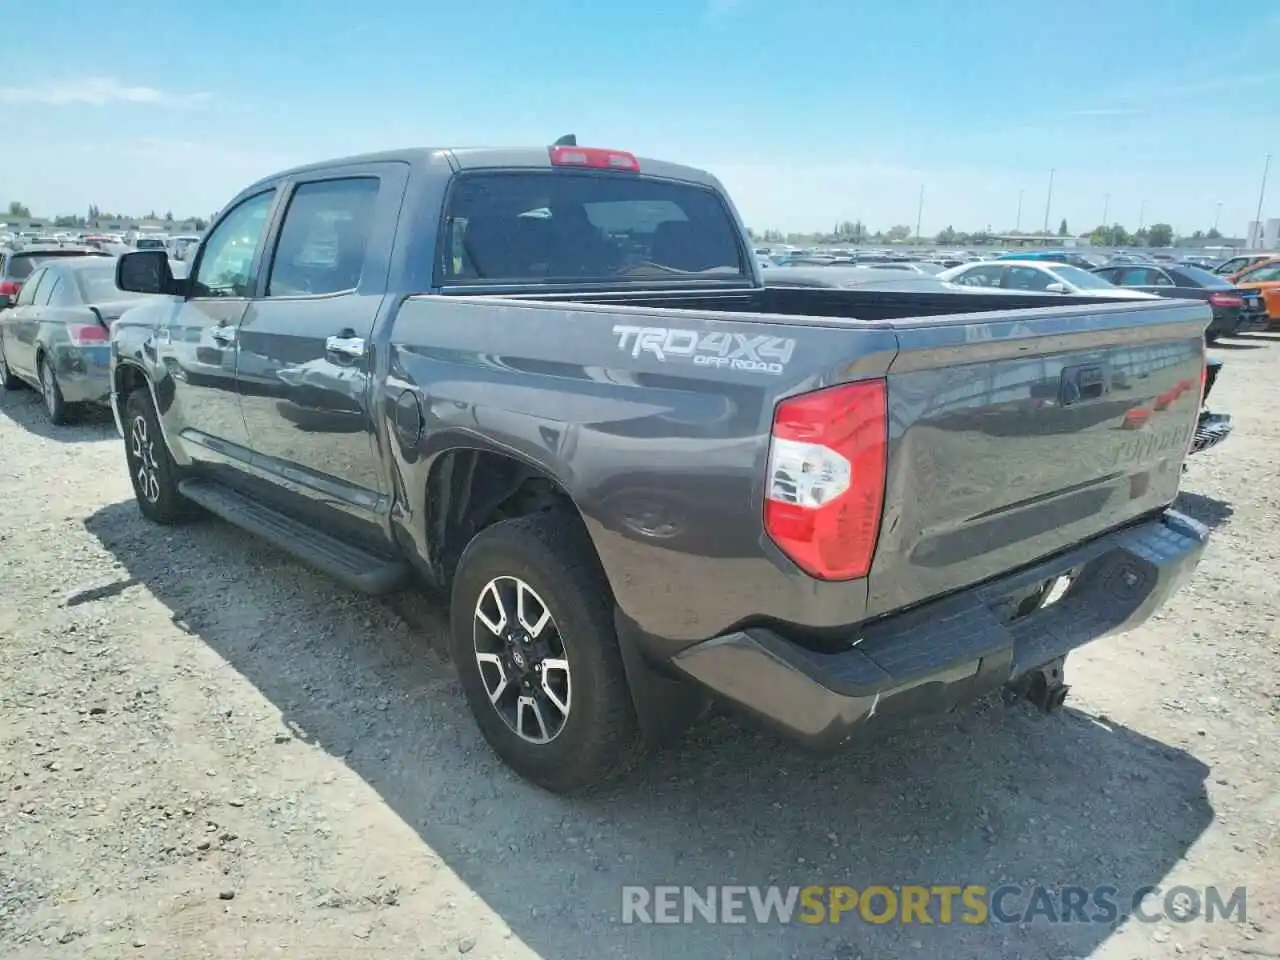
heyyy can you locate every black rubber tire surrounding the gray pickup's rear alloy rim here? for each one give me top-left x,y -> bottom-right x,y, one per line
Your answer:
449,512 -> 639,794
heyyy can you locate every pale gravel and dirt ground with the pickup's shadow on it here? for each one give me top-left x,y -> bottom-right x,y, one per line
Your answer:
0,335 -> 1280,960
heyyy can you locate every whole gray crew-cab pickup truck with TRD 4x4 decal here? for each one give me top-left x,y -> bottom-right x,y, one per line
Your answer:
111,145 -> 1210,791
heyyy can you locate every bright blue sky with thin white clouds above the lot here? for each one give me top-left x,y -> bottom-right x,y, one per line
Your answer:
0,0 -> 1280,233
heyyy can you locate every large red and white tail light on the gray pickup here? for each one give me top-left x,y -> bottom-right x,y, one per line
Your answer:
764,380 -> 888,580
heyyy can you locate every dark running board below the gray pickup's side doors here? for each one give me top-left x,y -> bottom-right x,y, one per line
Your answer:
178,477 -> 411,594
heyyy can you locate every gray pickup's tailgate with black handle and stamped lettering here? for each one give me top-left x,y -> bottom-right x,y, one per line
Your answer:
868,301 -> 1211,616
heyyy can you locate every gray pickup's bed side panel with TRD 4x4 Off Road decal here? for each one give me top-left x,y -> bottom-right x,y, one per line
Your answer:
379,297 -> 893,654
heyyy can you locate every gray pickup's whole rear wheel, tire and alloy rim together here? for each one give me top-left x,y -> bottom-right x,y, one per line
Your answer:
449,512 -> 637,794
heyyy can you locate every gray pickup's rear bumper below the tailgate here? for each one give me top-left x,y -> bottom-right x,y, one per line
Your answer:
673,511 -> 1208,749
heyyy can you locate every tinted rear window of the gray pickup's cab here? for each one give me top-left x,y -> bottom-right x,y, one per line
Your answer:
436,172 -> 748,285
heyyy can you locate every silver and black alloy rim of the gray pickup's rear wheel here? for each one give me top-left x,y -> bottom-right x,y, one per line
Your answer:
474,576 -> 572,744
